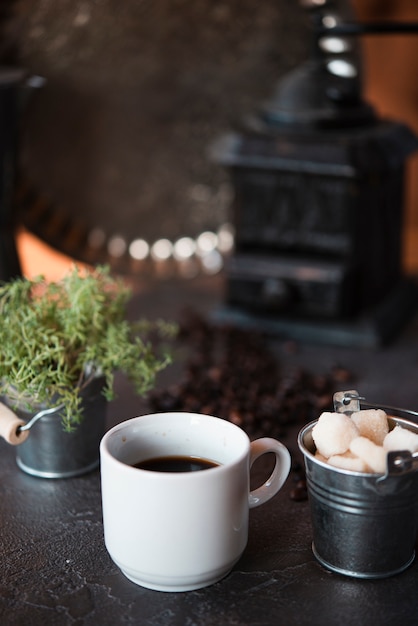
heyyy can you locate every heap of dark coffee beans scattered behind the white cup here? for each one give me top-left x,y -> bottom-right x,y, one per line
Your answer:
149,310 -> 350,446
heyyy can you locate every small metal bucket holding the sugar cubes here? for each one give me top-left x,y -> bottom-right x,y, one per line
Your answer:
298,392 -> 418,578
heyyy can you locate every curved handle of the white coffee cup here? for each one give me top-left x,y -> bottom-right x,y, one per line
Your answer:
248,437 -> 291,509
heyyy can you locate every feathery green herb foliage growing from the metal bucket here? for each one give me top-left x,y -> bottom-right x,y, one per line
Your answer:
0,266 -> 176,431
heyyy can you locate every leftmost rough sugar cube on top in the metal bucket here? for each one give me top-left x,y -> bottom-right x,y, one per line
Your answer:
312,411 -> 359,458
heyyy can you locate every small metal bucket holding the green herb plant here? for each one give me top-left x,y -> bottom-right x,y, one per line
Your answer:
2,379 -> 107,478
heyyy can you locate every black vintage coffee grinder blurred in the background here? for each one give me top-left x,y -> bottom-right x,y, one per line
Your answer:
214,0 -> 418,346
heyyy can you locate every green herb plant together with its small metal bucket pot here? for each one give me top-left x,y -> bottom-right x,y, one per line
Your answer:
0,266 -> 175,478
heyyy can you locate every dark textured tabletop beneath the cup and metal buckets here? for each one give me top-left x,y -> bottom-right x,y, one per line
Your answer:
0,279 -> 418,626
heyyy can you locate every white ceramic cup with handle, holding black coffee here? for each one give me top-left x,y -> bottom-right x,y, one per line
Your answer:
100,412 -> 290,591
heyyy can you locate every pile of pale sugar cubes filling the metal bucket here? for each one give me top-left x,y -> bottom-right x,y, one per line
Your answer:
312,409 -> 418,474
